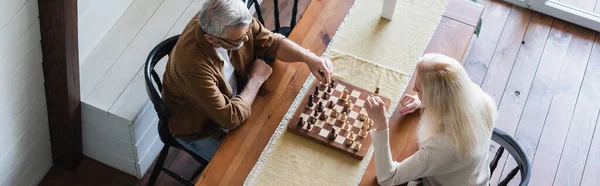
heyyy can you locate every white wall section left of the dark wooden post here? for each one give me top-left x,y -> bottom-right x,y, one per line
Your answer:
0,0 -> 52,186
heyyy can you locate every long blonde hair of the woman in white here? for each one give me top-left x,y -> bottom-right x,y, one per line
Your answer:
415,54 -> 496,155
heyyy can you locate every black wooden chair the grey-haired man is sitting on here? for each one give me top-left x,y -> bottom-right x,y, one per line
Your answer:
144,35 -> 208,186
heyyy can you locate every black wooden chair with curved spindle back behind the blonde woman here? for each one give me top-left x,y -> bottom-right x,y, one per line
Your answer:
490,128 -> 531,186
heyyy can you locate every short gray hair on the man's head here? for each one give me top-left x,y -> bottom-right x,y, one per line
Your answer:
198,0 -> 252,37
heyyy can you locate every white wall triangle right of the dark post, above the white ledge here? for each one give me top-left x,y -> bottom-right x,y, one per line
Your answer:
77,0 -> 134,64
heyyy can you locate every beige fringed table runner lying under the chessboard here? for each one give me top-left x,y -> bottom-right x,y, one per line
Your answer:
245,0 -> 447,186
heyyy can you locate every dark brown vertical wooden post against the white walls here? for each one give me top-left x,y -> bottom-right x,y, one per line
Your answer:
38,0 -> 83,170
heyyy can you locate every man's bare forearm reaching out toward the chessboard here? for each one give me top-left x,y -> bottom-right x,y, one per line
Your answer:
275,39 -> 318,62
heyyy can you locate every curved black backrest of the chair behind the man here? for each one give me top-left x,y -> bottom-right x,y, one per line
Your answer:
144,35 -> 179,143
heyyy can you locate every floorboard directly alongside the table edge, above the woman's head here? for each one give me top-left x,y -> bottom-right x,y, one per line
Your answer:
461,1 -> 512,85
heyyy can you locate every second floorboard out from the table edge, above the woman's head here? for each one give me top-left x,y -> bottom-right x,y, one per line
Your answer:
481,6 -> 531,105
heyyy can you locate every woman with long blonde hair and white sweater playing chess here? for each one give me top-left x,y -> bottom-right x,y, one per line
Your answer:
366,54 -> 496,186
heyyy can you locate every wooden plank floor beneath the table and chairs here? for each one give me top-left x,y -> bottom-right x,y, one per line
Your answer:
41,0 -> 600,185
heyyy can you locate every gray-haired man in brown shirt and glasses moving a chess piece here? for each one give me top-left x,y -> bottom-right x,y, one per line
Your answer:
162,0 -> 333,160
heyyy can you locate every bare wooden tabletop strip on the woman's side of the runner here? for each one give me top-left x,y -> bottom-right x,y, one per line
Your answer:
359,0 -> 486,185
